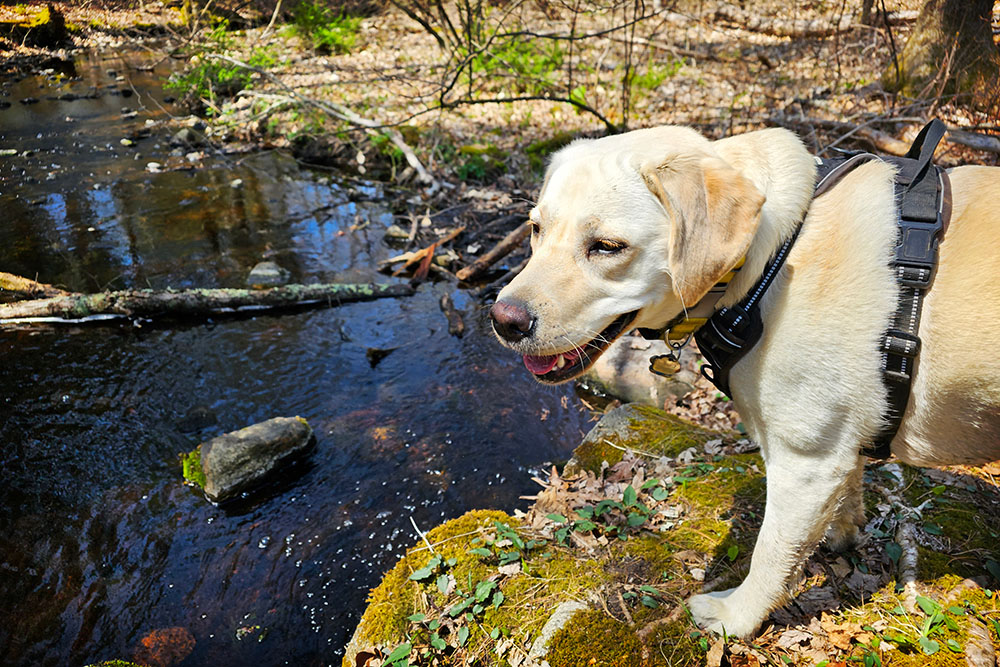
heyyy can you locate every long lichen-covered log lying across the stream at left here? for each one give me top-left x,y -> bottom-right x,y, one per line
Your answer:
0,283 -> 414,324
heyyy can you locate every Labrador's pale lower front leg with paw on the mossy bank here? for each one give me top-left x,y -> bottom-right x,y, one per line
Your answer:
688,450 -> 863,637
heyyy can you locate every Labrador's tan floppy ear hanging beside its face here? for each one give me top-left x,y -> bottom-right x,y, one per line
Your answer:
639,155 -> 764,306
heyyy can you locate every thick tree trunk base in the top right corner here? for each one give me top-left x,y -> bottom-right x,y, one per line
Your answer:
882,0 -> 1000,105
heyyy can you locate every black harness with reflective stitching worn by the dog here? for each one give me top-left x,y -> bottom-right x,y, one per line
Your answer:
640,120 -> 951,458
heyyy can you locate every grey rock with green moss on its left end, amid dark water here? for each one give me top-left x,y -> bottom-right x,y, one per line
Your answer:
201,417 -> 312,503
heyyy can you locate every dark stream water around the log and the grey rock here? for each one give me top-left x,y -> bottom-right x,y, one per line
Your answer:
0,49 -> 587,666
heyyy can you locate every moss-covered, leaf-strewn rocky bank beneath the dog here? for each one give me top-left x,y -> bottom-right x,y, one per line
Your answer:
343,405 -> 1000,667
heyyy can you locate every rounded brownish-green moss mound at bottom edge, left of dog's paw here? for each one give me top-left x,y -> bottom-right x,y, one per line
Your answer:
545,611 -> 642,667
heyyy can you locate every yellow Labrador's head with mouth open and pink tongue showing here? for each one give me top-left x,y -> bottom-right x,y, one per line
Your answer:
490,127 -> 764,383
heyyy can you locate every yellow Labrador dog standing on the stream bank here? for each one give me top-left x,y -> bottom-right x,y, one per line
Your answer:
490,127 -> 1000,636
